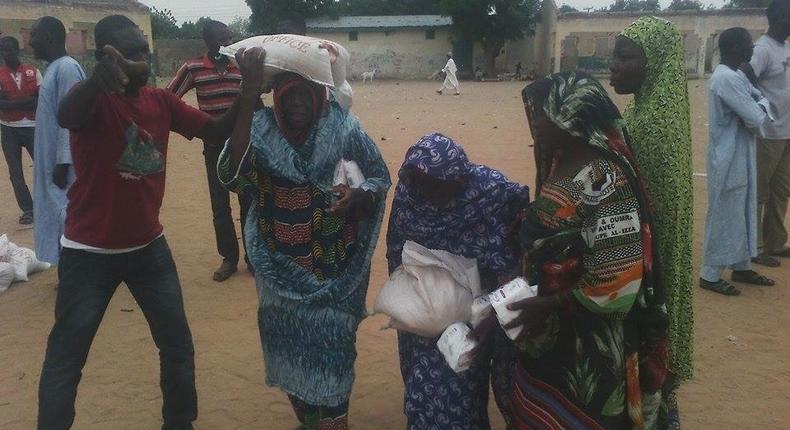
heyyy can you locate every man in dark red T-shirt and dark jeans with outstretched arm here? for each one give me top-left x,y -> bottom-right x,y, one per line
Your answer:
38,15 -> 246,430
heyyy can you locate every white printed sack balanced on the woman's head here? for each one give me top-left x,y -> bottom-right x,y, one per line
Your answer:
219,34 -> 353,110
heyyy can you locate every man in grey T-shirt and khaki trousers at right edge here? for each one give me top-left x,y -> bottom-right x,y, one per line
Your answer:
743,0 -> 790,267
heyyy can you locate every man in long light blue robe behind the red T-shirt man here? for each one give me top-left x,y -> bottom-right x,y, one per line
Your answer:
30,16 -> 85,264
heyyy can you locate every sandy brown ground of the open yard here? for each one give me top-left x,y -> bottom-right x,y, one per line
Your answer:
0,81 -> 790,430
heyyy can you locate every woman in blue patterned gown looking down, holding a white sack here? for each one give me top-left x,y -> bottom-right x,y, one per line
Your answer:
387,133 -> 529,430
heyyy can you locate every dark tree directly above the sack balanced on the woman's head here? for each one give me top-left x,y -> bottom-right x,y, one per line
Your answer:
246,0 -> 336,33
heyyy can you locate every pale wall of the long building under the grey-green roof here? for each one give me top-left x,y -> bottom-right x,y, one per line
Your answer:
308,29 -> 453,79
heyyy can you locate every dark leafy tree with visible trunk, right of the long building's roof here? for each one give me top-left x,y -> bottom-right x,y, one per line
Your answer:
441,0 -> 539,76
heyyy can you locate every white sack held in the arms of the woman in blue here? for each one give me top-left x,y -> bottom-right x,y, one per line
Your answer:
373,241 -> 480,338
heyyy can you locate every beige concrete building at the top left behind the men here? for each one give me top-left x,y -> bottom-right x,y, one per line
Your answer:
0,0 -> 154,69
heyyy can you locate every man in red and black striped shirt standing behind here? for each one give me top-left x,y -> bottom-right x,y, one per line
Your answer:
167,21 -> 251,282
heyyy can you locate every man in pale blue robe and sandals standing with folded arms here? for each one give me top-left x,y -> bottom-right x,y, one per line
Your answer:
699,27 -> 774,296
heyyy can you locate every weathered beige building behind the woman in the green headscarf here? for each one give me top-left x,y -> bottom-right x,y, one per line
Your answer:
554,9 -> 768,76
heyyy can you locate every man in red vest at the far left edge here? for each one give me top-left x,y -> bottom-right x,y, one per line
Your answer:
0,36 -> 42,225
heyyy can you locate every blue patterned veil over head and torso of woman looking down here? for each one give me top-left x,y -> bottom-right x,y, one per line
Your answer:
387,133 -> 529,274
